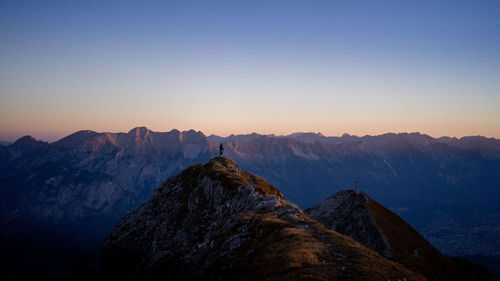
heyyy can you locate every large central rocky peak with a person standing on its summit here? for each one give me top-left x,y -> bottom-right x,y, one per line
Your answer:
101,157 -> 425,280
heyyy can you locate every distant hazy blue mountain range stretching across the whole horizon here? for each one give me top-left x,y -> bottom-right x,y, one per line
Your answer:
0,127 -> 500,274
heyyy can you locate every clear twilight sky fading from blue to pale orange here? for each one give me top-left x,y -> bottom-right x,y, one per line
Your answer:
0,0 -> 500,141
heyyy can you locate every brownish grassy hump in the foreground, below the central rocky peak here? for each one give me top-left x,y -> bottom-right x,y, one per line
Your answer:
223,213 -> 426,281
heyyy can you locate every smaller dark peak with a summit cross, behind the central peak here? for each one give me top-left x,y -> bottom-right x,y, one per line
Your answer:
305,190 -> 497,280
